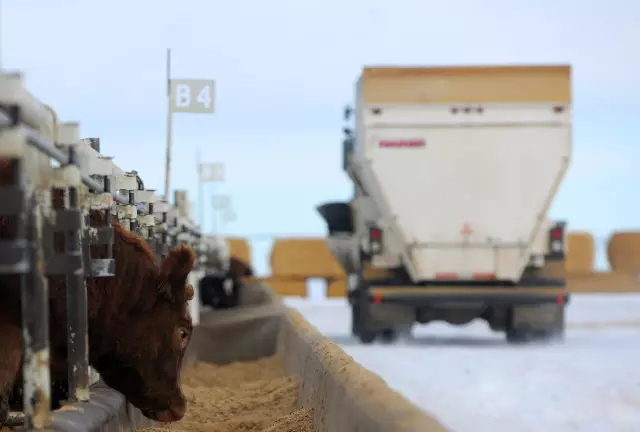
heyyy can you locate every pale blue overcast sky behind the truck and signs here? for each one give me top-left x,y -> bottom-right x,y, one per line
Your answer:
1,0 -> 640,271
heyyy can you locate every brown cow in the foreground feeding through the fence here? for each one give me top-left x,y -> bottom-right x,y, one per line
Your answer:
0,159 -> 195,425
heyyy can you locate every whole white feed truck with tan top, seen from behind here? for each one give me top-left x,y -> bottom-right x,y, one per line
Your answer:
317,65 -> 571,343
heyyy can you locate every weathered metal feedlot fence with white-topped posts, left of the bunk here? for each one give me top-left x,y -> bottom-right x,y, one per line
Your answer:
0,70 -> 215,430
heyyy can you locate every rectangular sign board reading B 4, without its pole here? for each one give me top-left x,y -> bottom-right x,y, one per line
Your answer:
171,79 -> 215,114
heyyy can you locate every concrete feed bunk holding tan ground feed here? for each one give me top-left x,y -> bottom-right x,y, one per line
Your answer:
23,284 -> 446,432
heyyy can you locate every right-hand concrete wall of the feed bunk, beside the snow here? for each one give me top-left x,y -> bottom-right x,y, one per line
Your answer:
277,309 -> 447,432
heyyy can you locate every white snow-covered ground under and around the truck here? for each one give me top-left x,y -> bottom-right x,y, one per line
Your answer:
287,294 -> 640,432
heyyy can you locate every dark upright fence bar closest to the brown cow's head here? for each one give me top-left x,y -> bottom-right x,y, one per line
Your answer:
65,187 -> 89,402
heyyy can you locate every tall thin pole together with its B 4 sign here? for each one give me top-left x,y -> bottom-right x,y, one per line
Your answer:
164,49 -> 215,203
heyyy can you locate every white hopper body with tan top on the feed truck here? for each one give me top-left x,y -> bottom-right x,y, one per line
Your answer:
348,67 -> 572,282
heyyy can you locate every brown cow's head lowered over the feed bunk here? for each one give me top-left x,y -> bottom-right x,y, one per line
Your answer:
96,246 -> 195,422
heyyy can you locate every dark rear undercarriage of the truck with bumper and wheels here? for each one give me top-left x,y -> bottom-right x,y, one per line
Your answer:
348,256 -> 570,344
